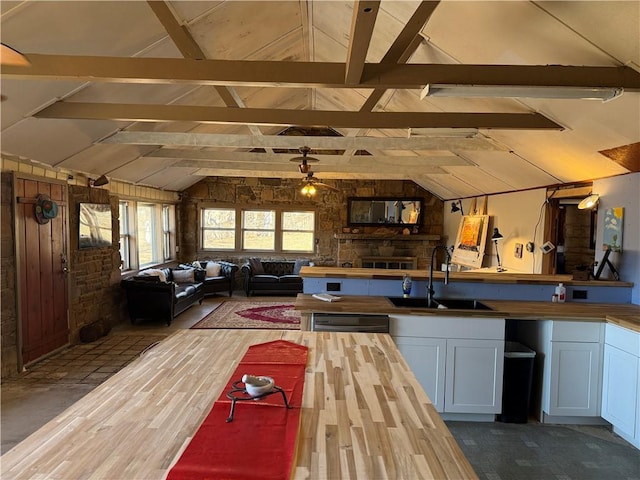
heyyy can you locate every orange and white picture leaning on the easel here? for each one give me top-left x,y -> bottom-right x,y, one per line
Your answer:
451,215 -> 489,268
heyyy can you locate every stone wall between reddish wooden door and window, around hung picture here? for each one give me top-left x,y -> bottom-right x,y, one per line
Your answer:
69,186 -> 125,343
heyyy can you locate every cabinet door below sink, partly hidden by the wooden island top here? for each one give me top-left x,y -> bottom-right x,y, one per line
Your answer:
393,337 -> 447,412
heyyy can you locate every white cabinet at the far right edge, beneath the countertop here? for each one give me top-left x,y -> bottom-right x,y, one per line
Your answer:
602,324 -> 640,448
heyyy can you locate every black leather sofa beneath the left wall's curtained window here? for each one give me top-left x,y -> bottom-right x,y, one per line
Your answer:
120,268 -> 204,325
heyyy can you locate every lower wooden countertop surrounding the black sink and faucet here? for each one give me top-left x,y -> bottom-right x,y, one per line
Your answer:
295,293 -> 640,332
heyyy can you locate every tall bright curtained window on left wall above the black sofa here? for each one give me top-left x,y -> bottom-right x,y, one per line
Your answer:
120,201 -> 176,271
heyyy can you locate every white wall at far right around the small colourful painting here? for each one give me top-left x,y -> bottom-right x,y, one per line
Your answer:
593,173 -> 640,305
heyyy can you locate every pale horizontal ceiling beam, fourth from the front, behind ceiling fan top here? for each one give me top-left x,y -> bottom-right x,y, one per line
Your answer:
145,148 -> 473,168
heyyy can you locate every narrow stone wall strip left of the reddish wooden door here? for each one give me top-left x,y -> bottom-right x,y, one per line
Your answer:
0,172 -> 18,378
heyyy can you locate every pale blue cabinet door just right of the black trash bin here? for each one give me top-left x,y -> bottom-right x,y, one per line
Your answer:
547,342 -> 602,417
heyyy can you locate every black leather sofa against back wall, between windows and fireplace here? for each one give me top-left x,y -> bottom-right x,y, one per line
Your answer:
240,258 -> 309,297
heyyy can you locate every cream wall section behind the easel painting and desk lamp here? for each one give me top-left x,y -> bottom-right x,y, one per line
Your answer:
444,188 -> 546,273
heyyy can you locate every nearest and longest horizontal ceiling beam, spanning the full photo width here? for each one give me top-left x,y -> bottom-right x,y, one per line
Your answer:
6,53 -> 640,91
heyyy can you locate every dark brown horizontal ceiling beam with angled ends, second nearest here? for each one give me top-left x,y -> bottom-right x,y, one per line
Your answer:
34,102 -> 563,130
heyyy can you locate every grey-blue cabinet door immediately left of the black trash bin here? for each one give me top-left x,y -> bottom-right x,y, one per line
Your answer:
444,339 -> 504,413
